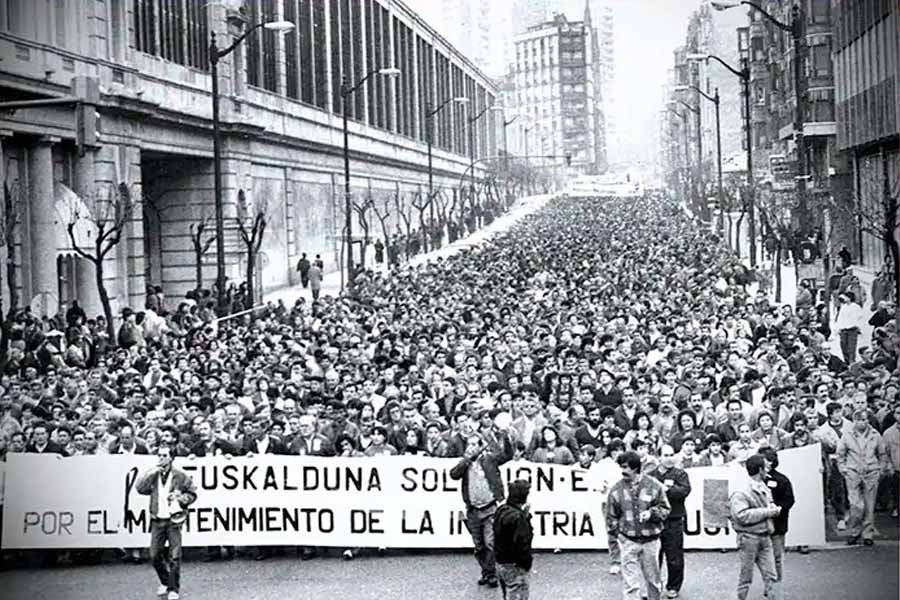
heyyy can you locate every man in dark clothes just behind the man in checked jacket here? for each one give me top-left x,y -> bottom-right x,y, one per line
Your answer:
650,444 -> 691,598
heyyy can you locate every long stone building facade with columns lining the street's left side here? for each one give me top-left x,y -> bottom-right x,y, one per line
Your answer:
0,0 -> 499,314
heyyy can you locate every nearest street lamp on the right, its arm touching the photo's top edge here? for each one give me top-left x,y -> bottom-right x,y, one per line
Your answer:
710,0 -> 809,238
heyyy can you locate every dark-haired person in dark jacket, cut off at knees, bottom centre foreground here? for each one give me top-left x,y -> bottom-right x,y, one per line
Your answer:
494,479 -> 534,600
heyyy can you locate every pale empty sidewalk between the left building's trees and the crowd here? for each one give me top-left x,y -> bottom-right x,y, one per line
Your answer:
263,195 -> 552,306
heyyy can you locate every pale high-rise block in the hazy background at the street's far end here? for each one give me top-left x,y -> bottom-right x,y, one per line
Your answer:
515,14 -> 606,173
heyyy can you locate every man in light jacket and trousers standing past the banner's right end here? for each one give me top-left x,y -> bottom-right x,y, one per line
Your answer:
836,408 -> 889,546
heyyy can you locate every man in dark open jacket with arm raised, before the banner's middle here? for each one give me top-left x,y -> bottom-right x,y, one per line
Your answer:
450,432 -> 513,588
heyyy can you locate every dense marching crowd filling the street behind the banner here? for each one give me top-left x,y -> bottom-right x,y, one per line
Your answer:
0,192 -> 900,592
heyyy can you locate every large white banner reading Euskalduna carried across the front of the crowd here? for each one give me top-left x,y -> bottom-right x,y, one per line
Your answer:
2,446 -> 825,549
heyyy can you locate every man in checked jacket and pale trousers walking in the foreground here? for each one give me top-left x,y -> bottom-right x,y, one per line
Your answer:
606,452 -> 671,600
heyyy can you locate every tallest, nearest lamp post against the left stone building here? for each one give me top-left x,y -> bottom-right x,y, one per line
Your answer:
209,21 -> 294,316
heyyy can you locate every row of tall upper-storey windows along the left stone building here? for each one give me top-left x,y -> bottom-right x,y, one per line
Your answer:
130,0 -> 493,155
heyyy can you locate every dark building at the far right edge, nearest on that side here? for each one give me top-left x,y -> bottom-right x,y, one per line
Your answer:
831,0 -> 900,282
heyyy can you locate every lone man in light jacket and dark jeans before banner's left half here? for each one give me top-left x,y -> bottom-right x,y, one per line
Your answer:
135,444 -> 197,600
